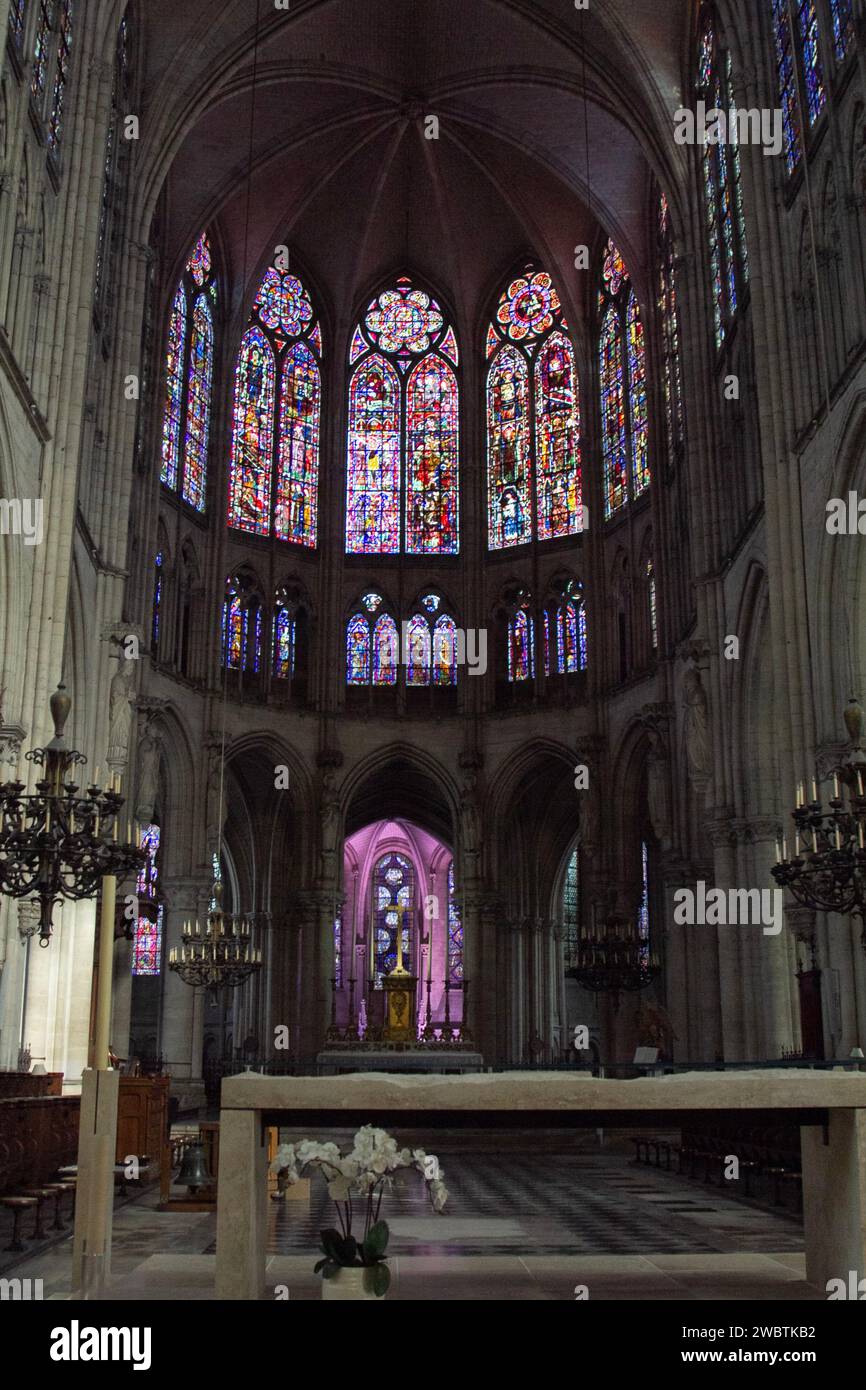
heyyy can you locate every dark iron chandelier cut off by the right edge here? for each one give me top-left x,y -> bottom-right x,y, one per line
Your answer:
771,699 -> 866,951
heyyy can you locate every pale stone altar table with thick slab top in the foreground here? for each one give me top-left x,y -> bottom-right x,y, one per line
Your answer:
217,1069 -> 866,1300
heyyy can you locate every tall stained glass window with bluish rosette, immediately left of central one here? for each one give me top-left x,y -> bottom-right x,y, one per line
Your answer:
228,265 -> 321,548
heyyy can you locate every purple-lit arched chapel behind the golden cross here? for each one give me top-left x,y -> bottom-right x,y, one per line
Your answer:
334,819 -> 463,1036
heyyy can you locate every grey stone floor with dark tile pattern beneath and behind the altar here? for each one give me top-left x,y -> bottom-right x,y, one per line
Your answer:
4,1134 -> 826,1301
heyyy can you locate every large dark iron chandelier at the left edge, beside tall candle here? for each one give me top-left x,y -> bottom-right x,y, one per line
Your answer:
0,685 -> 145,947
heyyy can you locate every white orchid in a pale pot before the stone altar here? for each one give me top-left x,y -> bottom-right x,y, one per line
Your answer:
271,1125 -> 448,1300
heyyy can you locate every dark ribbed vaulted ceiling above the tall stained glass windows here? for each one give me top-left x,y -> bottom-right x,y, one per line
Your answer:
139,0 -> 694,334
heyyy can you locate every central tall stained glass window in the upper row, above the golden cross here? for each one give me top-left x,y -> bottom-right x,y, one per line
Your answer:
346,277 -> 459,555
